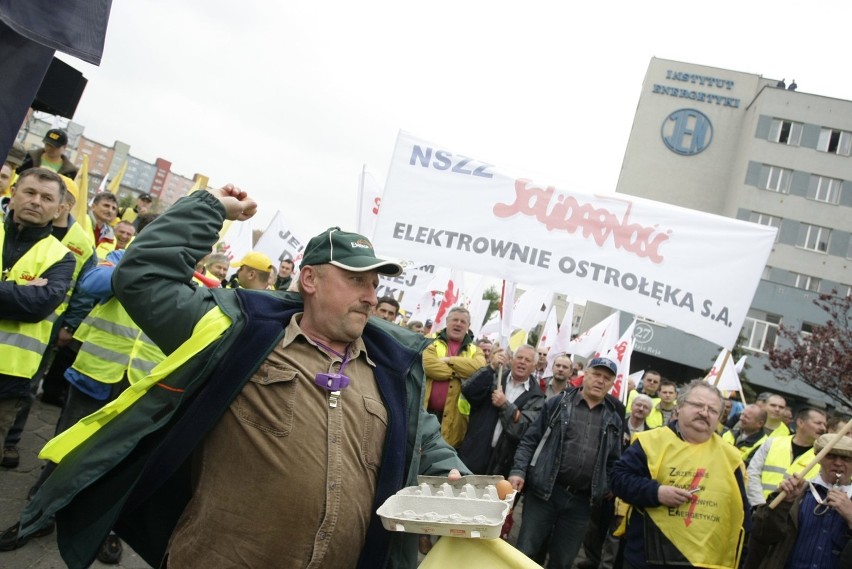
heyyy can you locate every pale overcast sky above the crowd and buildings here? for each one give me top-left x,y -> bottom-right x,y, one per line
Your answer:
56,0 -> 852,238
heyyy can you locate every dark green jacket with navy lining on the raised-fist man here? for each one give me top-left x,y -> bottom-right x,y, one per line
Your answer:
21,192 -> 469,567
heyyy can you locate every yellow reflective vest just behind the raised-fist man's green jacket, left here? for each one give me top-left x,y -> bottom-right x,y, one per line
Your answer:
71,297 -> 166,385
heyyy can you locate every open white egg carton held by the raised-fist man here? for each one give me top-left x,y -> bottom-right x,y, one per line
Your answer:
377,476 -> 515,539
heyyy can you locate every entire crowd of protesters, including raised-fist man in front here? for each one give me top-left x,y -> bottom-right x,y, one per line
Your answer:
0,129 -> 852,569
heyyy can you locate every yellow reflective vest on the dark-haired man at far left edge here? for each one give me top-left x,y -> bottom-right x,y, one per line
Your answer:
0,224 -> 68,379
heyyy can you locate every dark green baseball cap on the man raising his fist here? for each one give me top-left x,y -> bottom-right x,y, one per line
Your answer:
299,227 -> 402,277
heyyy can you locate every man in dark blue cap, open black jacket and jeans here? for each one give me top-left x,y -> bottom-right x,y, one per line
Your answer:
509,352 -> 624,569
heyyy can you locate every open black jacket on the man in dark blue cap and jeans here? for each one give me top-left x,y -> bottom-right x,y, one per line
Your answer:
511,388 -> 624,503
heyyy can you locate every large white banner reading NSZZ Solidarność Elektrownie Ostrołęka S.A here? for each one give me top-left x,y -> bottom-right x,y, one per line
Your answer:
373,133 -> 776,348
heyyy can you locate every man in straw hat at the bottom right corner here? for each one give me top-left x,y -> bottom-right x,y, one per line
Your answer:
744,435 -> 852,569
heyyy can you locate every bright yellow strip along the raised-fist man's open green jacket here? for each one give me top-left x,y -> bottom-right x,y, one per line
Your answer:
38,307 -> 232,462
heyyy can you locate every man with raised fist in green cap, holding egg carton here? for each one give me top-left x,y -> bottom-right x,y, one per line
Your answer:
15,185 -> 469,569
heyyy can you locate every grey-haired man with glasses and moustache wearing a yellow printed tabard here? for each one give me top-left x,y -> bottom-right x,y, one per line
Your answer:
611,380 -> 750,569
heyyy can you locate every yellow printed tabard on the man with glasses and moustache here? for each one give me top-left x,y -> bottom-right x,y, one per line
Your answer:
633,427 -> 745,569
